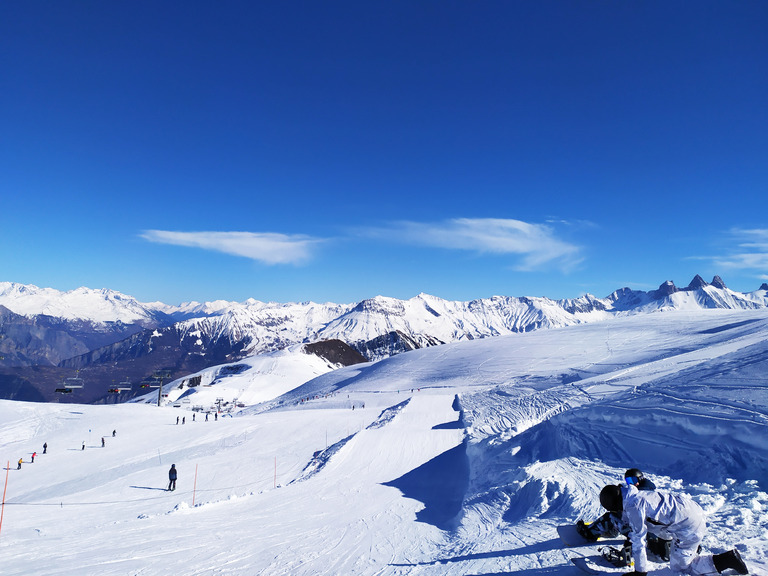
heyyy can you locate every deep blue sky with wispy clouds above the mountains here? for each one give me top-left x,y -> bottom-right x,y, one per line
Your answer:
0,0 -> 768,304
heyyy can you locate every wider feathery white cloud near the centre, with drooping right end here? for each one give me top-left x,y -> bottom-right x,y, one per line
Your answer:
365,218 -> 581,271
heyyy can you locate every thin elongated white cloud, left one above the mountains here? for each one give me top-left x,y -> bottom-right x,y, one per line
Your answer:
140,230 -> 323,264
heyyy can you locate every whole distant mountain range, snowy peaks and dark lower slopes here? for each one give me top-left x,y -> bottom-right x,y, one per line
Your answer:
0,275 -> 768,397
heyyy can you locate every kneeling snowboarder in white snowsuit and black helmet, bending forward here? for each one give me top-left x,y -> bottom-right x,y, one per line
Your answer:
600,484 -> 748,576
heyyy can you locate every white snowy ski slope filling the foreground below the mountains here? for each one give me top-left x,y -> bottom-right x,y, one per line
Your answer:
0,310 -> 768,576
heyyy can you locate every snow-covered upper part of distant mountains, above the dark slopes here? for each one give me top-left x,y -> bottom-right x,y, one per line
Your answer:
0,276 -> 768,359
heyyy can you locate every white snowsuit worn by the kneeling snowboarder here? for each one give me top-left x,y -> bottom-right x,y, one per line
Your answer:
622,486 -> 718,576
